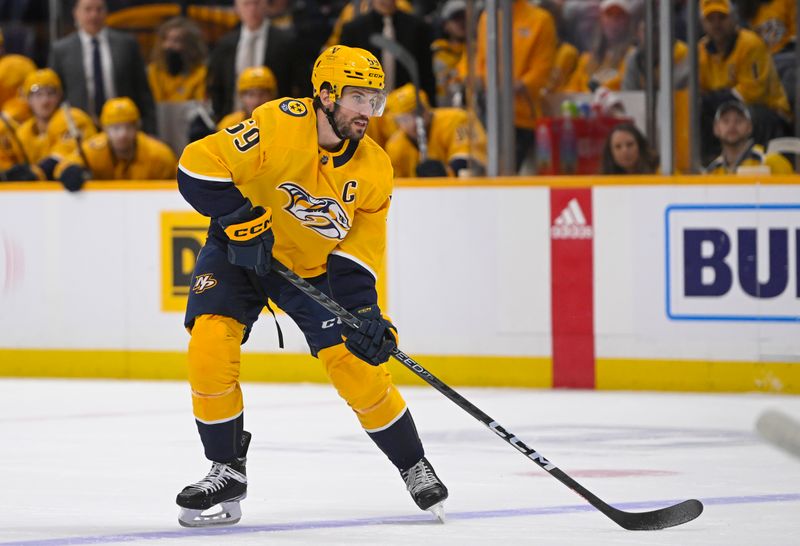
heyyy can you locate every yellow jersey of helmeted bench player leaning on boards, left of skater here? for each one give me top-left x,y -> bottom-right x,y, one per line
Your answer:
54,131 -> 176,180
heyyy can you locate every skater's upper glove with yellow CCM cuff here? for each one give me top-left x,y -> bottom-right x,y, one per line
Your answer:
217,200 -> 275,276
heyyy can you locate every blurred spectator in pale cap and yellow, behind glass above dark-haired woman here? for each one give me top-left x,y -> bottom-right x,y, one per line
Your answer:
566,0 -> 635,93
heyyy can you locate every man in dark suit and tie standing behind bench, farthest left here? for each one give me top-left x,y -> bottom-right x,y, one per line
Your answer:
48,0 -> 156,133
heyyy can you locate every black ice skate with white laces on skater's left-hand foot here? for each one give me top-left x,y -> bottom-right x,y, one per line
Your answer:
176,432 -> 251,527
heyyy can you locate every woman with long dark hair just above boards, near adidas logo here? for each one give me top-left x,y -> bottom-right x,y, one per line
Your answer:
600,123 -> 658,174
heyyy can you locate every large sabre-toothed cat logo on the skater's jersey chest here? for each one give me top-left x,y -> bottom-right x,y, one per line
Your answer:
278,182 -> 350,240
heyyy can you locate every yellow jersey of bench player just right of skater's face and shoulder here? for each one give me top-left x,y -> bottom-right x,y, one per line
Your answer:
386,108 -> 486,178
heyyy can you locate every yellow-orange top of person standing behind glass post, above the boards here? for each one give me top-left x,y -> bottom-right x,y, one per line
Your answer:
472,0 -> 558,129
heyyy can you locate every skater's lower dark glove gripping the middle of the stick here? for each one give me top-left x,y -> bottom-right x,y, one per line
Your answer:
342,305 -> 397,366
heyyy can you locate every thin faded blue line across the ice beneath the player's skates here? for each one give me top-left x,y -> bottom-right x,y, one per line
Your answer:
0,493 -> 800,546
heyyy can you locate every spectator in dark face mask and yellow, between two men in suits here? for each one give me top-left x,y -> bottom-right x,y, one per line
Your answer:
147,17 -> 208,102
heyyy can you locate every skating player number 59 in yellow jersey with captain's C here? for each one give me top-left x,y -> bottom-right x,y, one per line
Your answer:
177,46 -> 447,527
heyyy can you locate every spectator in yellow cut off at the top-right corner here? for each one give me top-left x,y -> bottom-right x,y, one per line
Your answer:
736,0 -> 800,109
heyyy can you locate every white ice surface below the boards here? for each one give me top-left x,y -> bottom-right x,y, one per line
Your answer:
0,380 -> 800,546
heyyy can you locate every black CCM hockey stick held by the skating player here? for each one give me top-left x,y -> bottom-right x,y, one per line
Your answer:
272,258 -> 703,531
